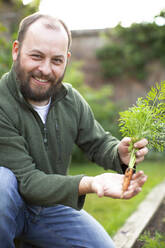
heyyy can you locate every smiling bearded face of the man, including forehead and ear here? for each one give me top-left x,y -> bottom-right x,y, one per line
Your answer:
13,21 -> 70,105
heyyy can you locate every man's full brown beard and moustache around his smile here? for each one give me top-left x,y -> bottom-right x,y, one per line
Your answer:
14,54 -> 66,102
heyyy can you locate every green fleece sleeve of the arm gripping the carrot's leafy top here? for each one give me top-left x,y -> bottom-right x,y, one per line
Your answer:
75,88 -> 124,173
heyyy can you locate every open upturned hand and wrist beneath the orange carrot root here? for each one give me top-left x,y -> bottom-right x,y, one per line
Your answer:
79,171 -> 147,199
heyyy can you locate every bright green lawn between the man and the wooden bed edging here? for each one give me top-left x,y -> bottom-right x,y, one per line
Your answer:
70,161 -> 165,236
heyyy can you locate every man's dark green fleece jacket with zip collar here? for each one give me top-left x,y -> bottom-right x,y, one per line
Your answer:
0,69 -> 122,209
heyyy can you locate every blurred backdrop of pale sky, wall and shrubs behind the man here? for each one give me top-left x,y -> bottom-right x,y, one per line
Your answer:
0,0 -> 165,162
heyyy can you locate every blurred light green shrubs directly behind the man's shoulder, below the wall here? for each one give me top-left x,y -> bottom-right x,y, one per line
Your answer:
64,62 -> 120,162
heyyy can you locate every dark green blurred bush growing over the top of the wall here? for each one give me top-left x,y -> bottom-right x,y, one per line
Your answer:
96,11 -> 165,80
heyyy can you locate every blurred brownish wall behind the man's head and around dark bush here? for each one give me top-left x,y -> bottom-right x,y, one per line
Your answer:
71,29 -> 165,106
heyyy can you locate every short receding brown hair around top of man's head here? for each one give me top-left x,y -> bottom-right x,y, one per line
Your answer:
18,12 -> 72,50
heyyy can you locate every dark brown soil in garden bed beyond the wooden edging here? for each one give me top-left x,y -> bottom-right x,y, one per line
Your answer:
133,199 -> 165,248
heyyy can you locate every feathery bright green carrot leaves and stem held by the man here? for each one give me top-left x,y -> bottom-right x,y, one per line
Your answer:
119,81 -> 165,167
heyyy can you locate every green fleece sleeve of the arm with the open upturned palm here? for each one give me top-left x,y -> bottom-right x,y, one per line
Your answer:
0,109 -> 85,210
